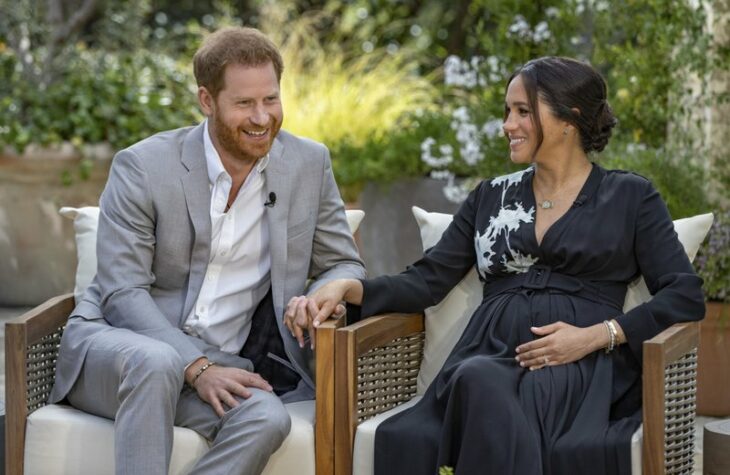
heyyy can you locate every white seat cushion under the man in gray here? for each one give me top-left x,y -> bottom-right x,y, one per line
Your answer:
25,401 -> 314,475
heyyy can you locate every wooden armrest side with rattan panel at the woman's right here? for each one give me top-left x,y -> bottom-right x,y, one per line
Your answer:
642,322 -> 699,474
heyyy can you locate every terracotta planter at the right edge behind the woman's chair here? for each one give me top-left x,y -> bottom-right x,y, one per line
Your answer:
697,302 -> 730,417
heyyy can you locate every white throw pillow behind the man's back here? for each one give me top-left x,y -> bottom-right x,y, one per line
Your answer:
58,206 -> 365,302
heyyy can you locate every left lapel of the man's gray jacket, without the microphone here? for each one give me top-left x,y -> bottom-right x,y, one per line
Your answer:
181,122 -> 211,324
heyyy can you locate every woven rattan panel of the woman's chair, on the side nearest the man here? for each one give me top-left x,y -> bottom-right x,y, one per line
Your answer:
357,332 -> 424,422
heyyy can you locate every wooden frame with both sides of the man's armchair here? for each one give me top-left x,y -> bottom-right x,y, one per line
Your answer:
5,294 -> 344,475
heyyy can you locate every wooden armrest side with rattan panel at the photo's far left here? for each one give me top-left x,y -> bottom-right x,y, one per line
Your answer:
5,293 -> 74,475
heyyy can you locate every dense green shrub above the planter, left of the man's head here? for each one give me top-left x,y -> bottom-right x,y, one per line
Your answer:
0,46 -> 199,151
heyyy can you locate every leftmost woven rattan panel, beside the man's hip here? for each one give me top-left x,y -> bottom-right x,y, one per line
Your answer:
25,326 -> 65,414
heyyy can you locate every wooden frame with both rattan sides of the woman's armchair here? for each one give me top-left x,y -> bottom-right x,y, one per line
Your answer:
334,314 -> 699,475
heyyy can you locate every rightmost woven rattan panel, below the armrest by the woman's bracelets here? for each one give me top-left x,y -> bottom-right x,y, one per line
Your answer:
664,349 -> 697,474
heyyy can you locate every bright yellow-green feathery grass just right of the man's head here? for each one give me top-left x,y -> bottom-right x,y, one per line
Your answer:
268,10 -> 435,150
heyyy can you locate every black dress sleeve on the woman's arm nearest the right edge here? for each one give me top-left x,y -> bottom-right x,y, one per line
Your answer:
616,181 -> 705,362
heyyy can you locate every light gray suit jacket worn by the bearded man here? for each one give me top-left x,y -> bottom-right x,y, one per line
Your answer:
50,123 -> 365,402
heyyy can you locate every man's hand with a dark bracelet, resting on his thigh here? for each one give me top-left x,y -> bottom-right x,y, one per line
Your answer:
185,358 -> 273,417
